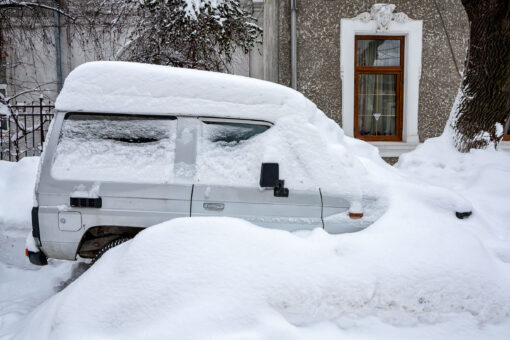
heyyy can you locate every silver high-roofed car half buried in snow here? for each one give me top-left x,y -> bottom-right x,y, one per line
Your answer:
28,62 -> 370,264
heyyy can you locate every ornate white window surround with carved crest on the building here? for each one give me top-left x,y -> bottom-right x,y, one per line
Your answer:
340,4 -> 423,157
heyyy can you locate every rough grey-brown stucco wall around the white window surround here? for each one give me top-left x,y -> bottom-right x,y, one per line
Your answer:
279,0 -> 469,141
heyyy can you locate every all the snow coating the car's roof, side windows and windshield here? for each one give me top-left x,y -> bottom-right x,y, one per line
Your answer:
52,62 -> 368,202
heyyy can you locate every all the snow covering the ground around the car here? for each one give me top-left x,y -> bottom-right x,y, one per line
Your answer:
0,131 -> 510,339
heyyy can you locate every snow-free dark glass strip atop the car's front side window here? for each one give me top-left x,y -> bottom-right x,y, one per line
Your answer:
204,122 -> 269,145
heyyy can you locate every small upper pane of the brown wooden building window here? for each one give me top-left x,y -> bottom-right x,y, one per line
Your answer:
356,39 -> 400,66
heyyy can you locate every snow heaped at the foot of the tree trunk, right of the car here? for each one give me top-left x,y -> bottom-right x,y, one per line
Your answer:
396,135 -> 510,262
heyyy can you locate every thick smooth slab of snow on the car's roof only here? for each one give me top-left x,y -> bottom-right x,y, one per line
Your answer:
55,61 -> 317,122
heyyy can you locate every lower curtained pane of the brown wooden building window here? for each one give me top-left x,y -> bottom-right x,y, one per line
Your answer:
358,74 -> 397,136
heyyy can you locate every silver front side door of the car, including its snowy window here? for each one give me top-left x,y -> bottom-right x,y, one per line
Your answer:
191,118 -> 323,231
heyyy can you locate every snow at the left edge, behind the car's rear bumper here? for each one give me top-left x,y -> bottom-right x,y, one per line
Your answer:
0,157 -> 73,337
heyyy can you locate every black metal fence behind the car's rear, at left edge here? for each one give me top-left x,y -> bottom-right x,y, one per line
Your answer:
0,99 -> 55,162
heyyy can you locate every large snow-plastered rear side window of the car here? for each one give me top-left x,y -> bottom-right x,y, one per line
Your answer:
52,113 -> 177,183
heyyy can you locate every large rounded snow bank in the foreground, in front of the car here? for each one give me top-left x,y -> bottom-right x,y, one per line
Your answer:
13,211 -> 510,339
